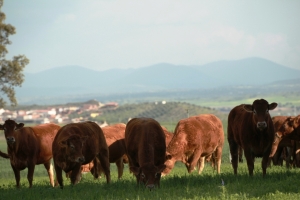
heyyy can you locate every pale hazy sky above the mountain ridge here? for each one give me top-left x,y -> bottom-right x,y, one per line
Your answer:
2,0 -> 300,72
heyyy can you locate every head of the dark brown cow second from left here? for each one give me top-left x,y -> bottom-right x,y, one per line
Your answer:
59,135 -> 87,163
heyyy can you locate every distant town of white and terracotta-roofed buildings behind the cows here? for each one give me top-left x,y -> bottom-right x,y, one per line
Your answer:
0,100 -> 118,126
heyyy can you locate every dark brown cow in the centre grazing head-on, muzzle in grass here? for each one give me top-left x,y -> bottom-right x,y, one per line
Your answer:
125,118 -> 166,190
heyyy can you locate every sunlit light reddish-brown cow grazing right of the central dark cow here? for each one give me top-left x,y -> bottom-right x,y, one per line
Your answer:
163,114 -> 224,175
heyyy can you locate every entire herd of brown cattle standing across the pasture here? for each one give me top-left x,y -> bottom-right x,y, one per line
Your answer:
0,99 -> 300,190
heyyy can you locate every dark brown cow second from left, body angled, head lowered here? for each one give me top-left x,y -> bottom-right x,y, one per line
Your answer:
52,121 -> 110,188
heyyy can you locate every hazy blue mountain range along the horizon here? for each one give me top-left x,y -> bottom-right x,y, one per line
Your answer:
16,57 -> 300,104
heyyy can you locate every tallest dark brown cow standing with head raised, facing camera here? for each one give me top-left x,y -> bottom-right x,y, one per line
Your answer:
227,99 -> 277,176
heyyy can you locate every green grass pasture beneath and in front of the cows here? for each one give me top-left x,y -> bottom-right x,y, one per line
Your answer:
0,133 -> 300,199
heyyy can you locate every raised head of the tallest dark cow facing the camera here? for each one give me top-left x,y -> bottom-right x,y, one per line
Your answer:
244,99 -> 277,131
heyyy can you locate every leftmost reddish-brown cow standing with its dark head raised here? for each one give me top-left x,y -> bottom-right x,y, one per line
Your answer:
0,119 -> 60,187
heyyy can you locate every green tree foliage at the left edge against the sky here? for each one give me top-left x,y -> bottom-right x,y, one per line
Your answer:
0,0 -> 29,108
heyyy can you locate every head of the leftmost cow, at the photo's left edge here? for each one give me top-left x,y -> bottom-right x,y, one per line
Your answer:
0,119 -> 24,145
